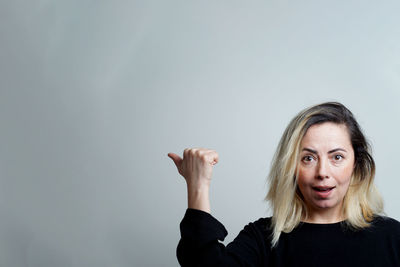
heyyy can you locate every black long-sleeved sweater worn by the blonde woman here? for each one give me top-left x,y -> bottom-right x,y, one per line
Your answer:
177,209 -> 400,267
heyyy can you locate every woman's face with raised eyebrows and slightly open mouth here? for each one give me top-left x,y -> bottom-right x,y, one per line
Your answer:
297,122 -> 354,219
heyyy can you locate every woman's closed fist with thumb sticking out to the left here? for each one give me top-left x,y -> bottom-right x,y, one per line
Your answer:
168,148 -> 218,187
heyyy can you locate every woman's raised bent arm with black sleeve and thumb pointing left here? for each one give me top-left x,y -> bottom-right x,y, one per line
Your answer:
168,148 -> 267,267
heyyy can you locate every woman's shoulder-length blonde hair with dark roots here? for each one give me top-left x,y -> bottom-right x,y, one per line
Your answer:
265,102 -> 383,246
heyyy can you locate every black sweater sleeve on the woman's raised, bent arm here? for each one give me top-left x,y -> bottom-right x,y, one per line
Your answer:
177,209 -> 269,267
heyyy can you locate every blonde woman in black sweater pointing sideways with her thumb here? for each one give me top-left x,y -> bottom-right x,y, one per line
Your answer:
168,102 -> 400,267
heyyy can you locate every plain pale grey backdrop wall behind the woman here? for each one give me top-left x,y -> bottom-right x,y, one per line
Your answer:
0,0 -> 400,267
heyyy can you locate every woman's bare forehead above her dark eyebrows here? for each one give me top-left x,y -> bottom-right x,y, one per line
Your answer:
301,122 -> 351,146
